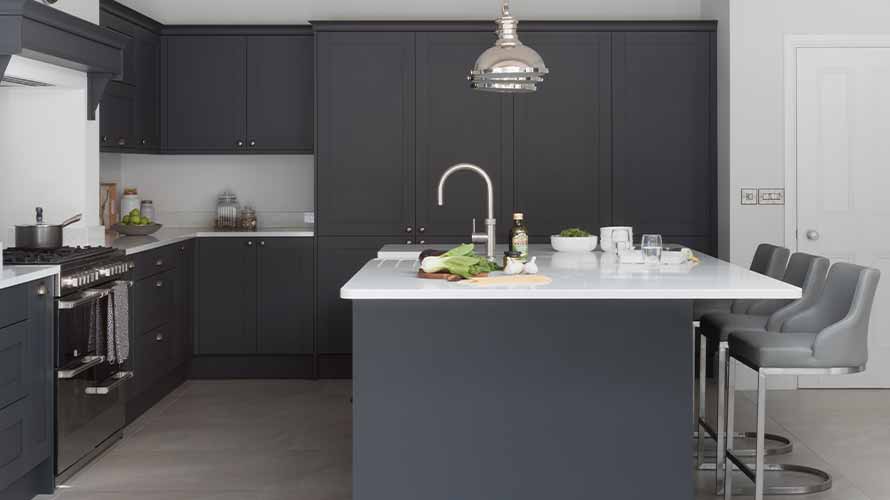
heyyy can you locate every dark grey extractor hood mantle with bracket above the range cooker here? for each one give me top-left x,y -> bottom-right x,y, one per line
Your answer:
0,0 -> 127,120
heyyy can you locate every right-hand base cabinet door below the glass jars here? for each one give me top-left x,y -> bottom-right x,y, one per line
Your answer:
256,238 -> 315,354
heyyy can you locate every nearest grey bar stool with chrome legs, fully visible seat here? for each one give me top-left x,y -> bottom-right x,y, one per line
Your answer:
723,263 -> 881,500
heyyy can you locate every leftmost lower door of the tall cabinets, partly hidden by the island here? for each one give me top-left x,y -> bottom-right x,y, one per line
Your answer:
316,237 -> 396,355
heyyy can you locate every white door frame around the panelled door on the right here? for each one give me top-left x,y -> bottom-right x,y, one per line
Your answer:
784,34 -> 890,252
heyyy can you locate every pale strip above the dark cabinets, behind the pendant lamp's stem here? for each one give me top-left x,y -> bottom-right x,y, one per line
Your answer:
119,0 -> 701,25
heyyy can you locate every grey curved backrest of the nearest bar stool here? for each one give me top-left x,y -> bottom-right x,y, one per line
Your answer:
782,262 -> 881,367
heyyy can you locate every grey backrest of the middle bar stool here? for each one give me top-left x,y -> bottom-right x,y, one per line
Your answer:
760,252 -> 829,332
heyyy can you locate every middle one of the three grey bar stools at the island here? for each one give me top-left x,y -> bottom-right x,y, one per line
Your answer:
697,253 -> 829,493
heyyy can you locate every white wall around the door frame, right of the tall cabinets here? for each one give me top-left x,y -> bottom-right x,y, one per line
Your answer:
730,0 -> 890,270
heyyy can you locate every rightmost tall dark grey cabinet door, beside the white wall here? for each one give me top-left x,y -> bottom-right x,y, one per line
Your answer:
612,32 -> 717,253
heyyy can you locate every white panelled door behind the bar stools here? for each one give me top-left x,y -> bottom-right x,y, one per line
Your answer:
796,47 -> 890,388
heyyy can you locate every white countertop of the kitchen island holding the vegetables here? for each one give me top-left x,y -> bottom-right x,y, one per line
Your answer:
340,245 -> 801,300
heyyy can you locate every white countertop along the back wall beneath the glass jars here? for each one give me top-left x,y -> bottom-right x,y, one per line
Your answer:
105,226 -> 315,255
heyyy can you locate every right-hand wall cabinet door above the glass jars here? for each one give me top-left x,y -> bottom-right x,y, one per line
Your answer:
247,34 -> 315,152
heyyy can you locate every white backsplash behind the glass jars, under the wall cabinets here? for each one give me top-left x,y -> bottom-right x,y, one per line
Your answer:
101,153 -> 315,227
